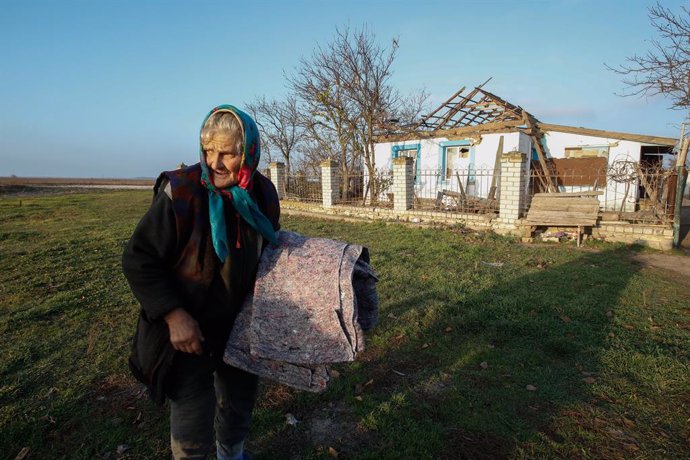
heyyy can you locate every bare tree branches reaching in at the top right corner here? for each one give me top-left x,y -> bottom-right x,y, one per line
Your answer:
606,2 -> 690,109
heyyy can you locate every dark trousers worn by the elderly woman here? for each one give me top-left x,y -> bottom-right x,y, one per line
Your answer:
166,352 -> 258,460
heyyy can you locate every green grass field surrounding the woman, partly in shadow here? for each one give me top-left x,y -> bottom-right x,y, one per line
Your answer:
0,191 -> 690,459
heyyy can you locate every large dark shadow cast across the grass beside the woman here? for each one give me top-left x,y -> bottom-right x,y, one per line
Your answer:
250,249 -> 636,459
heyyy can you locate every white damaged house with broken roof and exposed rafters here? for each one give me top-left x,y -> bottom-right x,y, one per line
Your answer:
375,83 -> 677,222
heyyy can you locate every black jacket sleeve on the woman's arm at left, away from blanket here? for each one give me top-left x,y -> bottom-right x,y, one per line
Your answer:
122,188 -> 184,320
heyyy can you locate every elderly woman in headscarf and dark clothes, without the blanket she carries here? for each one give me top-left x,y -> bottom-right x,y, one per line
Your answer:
122,105 -> 280,459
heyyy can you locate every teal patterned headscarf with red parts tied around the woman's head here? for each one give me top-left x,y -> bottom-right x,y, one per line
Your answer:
199,104 -> 276,261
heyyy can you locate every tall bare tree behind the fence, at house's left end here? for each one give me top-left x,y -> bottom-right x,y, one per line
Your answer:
288,27 -> 426,201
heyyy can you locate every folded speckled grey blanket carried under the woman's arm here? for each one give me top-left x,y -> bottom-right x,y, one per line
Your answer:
223,231 -> 378,392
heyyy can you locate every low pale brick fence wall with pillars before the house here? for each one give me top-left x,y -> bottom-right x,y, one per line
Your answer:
270,152 -> 673,250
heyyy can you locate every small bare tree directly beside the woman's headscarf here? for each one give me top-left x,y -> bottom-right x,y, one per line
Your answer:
247,95 -> 304,177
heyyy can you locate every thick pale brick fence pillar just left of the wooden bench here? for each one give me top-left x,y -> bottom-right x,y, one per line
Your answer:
499,151 -> 529,226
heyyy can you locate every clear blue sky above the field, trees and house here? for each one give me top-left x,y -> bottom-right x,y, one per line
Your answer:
0,0 -> 688,177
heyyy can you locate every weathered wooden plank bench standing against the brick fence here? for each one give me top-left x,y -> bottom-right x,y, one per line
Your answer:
524,191 -> 603,247
